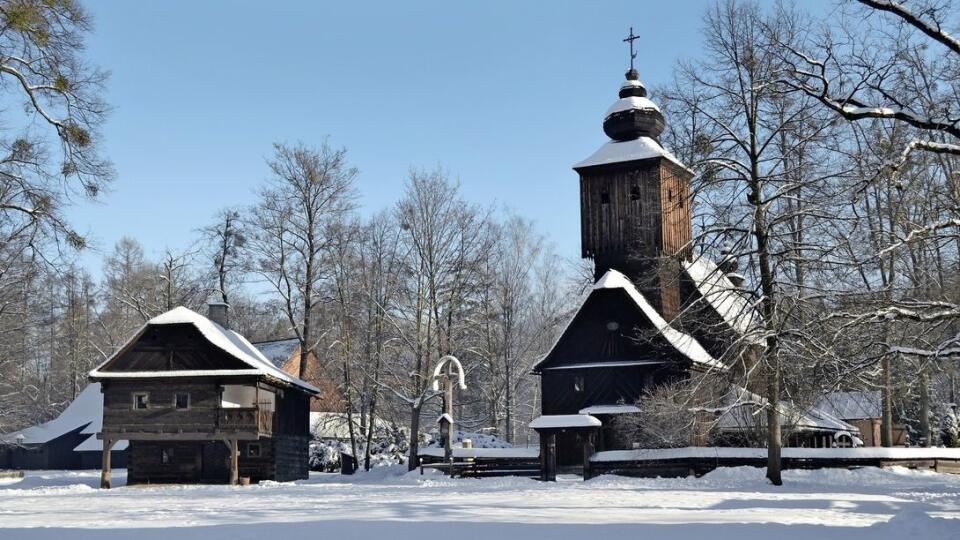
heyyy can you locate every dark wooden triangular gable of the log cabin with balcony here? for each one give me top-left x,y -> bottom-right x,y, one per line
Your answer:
99,324 -> 250,373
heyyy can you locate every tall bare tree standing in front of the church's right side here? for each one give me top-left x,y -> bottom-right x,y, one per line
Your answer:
668,0 -> 842,485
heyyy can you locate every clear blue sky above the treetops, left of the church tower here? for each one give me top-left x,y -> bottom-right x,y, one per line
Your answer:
71,0 -> 736,274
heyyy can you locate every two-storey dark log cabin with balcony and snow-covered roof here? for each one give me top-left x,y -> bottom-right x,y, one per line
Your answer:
90,304 -> 319,488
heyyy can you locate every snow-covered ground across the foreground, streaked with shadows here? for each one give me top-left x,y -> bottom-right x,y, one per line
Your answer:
0,467 -> 960,540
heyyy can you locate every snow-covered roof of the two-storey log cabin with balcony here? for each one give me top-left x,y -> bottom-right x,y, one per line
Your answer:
90,306 -> 320,394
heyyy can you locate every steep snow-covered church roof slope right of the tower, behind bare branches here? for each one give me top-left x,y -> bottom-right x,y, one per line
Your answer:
683,255 -> 763,345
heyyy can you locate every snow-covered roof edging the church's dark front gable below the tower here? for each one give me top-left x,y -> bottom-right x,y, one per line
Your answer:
532,270 -> 729,371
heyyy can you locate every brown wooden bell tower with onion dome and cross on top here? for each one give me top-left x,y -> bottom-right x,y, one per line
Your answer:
573,34 -> 693,319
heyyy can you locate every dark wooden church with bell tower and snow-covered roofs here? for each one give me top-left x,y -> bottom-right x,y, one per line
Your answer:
531,52 -> 855,470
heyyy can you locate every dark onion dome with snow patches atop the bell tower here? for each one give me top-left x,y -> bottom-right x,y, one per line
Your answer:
603,69 -> 663,141
